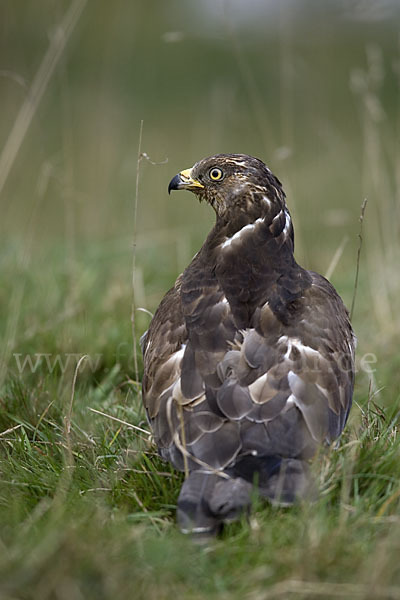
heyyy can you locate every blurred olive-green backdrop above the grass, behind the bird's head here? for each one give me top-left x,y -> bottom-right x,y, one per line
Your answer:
0,0 -> 400,351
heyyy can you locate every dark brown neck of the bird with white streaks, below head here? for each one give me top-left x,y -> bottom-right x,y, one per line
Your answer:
199,203 -> 306,327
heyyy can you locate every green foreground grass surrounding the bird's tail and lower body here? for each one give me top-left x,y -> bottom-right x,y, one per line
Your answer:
0,352 -> 400,599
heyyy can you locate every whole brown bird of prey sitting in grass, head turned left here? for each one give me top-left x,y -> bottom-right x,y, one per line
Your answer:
141,154 -> 355,535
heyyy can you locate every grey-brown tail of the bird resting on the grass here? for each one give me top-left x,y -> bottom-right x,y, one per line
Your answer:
177,456 -> 315,539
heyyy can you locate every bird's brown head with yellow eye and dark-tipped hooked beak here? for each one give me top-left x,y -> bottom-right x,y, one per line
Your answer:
168,154 -> 285,218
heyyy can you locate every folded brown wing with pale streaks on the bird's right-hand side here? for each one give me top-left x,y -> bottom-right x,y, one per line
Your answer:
248,273 -> 354,443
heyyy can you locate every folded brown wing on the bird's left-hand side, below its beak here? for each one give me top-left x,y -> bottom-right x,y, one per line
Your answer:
143,253 -> 240,469
